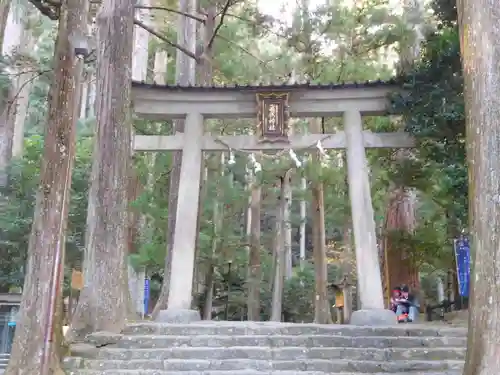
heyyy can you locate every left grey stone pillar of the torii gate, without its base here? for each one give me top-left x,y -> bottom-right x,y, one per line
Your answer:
168,113 -> 204,310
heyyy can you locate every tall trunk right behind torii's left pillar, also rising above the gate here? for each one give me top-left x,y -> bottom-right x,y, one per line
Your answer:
152,0 -> 197,317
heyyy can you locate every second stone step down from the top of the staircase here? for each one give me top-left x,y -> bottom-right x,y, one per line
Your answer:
103,334 -> 467,349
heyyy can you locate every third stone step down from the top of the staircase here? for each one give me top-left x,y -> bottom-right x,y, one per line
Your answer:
92,346 -> 466,361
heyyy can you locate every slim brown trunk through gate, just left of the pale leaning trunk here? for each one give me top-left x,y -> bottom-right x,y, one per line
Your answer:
247,176 -> 262,321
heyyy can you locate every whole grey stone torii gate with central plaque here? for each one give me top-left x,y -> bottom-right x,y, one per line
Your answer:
132,81 -> 414,325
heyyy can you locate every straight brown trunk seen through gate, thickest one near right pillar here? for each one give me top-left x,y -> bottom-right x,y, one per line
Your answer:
311,119 -> 332,324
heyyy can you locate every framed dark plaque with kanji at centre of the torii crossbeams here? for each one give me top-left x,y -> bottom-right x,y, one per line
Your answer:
256,92 -> 289,142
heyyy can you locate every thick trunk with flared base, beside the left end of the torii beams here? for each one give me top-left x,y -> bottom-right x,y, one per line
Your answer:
71,0 -> 134,338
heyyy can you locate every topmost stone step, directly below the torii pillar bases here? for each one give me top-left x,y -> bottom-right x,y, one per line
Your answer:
119,321 -> 467,337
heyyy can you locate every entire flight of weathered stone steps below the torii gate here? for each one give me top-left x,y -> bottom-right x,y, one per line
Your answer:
65,322 -> 466,375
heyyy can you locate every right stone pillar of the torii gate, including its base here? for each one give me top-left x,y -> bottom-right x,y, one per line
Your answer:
344,111 -> 396,325
